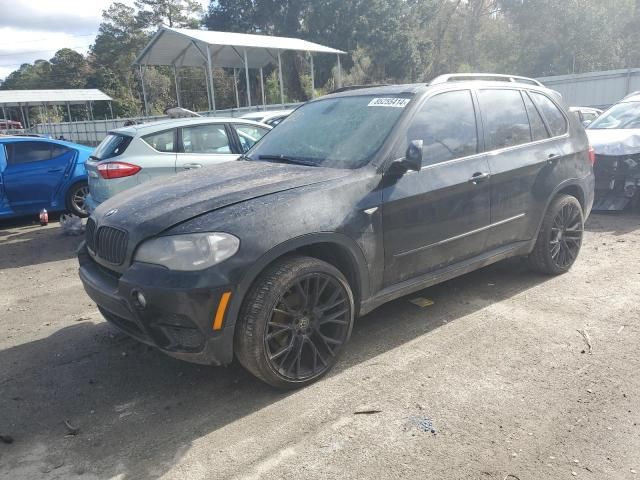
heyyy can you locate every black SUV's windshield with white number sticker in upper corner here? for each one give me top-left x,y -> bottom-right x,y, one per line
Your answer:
247,95 -> 411,168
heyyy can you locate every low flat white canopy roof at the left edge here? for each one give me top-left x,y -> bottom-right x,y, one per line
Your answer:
0,88 -> 111,107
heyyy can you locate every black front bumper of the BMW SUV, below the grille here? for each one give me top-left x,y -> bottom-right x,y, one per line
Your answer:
78,243 -> 234,365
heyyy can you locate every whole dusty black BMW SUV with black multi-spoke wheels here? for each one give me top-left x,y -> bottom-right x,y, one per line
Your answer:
79,80 -> 594,388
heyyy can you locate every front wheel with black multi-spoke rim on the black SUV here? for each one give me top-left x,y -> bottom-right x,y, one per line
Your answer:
235,256 -> 354,389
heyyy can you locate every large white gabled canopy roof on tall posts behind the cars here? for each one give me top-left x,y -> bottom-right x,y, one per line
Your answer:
134,26 -> 345,68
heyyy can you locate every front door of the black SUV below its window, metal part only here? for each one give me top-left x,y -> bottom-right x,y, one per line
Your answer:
383,156 -> 490,285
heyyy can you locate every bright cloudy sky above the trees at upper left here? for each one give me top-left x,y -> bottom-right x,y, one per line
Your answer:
0,0 -> 208,79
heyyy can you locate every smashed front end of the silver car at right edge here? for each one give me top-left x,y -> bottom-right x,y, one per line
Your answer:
593,153 -> 640,211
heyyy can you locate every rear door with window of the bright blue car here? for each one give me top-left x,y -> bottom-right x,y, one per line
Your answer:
4,142 -> 76,211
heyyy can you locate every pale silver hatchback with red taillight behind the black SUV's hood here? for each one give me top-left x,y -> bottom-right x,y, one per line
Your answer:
86,117 -> 271,211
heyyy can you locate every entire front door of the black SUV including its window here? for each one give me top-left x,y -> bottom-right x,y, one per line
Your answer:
383,90 -> 490,285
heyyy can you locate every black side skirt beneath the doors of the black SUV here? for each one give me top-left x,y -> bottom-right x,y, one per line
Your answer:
360,239 -> 535,315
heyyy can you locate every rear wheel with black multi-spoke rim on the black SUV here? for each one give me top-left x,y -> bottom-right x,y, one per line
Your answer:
529,191 -> 584,275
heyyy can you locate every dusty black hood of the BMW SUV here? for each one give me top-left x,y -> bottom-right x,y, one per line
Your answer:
93,161 -> 348,237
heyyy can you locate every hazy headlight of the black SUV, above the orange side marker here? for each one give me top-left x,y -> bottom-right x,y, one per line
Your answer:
134,233 -> 240,271
